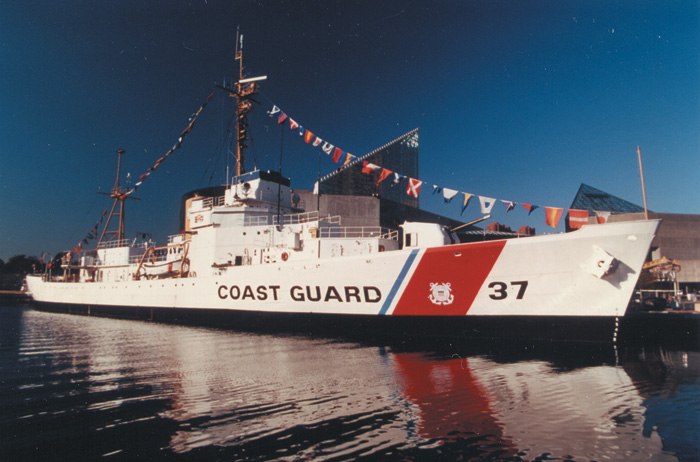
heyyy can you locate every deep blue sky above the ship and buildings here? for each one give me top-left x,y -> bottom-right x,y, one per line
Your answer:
0,0 -> 700,259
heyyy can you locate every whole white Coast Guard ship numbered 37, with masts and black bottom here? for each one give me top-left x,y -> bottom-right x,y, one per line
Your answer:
26,40 -> 659,342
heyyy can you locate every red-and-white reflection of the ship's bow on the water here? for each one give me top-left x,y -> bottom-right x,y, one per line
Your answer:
396,355 -> 662,460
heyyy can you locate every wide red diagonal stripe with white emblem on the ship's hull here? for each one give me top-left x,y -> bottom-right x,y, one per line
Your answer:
392,241 -> 506,316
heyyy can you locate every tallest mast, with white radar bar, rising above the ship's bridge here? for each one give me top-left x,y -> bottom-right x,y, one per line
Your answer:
217,29 -> 267,181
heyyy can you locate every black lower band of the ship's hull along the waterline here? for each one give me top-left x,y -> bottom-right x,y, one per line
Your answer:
28,302 -> 619,343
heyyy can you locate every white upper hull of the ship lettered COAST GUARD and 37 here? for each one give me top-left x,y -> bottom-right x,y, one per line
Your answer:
27,221 -> 658,342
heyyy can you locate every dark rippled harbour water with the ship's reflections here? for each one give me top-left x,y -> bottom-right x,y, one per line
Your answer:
0,307 -> 700,461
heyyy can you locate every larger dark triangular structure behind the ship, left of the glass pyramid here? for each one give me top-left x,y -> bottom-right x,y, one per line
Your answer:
319,128 -> 419,208
